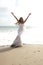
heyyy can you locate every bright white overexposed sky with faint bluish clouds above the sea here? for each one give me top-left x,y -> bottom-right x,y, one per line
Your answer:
0,0 -> 43,27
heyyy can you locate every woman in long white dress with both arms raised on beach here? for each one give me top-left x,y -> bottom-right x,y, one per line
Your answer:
11,12 -> 31,48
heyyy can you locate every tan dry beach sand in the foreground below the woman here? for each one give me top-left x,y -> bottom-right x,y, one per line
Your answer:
0,45 -> 43,65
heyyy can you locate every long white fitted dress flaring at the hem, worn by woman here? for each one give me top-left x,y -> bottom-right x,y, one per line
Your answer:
11,24 -> 24,47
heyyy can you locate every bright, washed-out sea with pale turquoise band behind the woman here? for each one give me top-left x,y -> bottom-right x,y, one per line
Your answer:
0,26 -> 43,46
